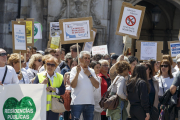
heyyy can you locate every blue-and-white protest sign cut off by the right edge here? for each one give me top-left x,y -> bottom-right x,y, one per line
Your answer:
168,41 -> 180,57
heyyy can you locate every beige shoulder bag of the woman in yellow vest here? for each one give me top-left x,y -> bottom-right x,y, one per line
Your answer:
48,79 -> 66,113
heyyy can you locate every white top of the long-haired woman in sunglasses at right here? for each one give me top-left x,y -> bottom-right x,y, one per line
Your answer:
155,75 -> 174,96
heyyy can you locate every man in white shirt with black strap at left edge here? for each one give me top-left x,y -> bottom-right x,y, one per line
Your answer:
0,48 -> 19,85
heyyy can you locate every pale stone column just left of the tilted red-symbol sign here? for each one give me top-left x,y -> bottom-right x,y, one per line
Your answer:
109,0 -> 123,55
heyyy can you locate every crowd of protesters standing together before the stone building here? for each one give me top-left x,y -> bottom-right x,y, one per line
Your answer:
0,45 -> 180,120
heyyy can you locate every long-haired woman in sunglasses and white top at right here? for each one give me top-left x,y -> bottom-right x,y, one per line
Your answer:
155,59 -> 174,97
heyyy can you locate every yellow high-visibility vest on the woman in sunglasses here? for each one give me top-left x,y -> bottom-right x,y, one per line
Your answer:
38,72 -> 63,111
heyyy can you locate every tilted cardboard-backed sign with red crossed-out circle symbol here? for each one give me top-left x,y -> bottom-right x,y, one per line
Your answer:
116,2 -> 146,39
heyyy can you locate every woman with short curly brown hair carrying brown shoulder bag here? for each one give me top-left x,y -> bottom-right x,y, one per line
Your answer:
106,61 -> 130,120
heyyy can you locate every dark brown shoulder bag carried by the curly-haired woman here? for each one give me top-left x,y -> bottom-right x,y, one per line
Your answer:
99,77 -> 119,110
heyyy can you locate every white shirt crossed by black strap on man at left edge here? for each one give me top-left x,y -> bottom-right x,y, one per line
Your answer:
0,65 -> 19,84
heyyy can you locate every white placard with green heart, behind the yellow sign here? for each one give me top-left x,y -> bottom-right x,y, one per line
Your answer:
34,23 -> 42,39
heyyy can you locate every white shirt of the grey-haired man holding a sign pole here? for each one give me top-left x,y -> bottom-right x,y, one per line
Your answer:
70,67 -> 97,105
